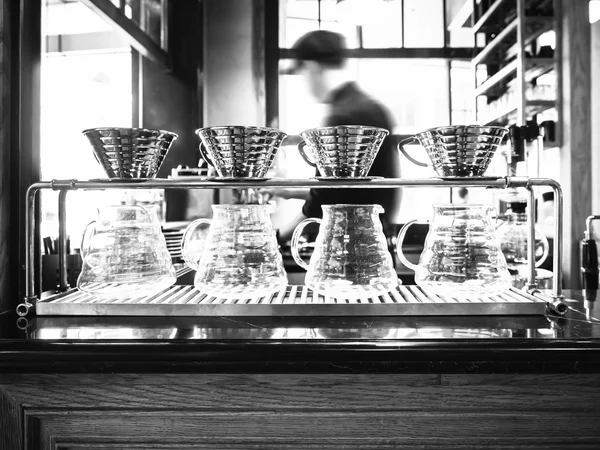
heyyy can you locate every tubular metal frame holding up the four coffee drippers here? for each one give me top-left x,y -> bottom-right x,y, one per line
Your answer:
17,177 -> 566,316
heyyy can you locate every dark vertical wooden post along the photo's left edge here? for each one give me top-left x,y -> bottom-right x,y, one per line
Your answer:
0,0 -> 42,309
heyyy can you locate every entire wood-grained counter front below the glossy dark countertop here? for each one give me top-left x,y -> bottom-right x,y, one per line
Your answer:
0,374 -> 600,450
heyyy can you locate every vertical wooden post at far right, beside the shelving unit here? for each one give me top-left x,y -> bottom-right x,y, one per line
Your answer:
558,0 -> 592,289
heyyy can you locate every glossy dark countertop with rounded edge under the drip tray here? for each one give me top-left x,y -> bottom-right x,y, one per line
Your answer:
0,291 -> 600,373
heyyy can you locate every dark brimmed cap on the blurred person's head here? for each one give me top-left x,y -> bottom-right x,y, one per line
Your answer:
282,30 -> 346,74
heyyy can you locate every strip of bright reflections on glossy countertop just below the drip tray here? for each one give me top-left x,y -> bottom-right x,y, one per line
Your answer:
28,316 -> 560,345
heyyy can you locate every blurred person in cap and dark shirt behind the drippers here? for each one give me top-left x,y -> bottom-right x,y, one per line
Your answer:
272,30 -> 401,242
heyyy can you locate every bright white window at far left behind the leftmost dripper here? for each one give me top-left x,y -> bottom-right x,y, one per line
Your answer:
40,3 -> 137,244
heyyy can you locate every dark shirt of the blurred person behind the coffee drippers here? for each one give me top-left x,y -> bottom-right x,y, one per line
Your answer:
302,82 -> 401,235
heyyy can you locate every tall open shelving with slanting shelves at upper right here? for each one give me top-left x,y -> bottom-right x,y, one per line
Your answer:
471,0 -> 561,126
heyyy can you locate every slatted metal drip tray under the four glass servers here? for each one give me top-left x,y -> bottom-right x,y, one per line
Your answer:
36,286 -> 547,317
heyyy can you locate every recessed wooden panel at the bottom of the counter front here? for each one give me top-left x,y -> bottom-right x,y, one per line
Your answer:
25,408 -> 600,450
